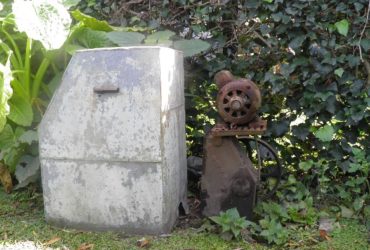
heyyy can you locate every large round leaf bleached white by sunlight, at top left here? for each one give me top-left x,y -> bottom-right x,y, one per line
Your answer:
13,0 -> 72,50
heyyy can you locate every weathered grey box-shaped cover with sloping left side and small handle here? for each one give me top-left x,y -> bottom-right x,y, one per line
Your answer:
39,47 -> 186,234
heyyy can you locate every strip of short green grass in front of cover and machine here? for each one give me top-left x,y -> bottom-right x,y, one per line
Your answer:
0,190 -> 369,250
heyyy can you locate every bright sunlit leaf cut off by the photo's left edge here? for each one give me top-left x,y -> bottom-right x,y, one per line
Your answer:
0,54 -> 13,132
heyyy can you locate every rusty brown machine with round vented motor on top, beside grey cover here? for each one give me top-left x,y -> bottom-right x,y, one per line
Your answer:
201,70 -> 282,219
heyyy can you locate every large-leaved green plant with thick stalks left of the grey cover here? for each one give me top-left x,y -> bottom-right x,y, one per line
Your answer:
0,1 -> 71,172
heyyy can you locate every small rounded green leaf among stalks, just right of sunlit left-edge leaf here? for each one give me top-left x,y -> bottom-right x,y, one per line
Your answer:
8,95 -> 33,126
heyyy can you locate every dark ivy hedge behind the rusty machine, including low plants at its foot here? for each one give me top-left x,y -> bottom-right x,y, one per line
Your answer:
71,0 -> 370,244
